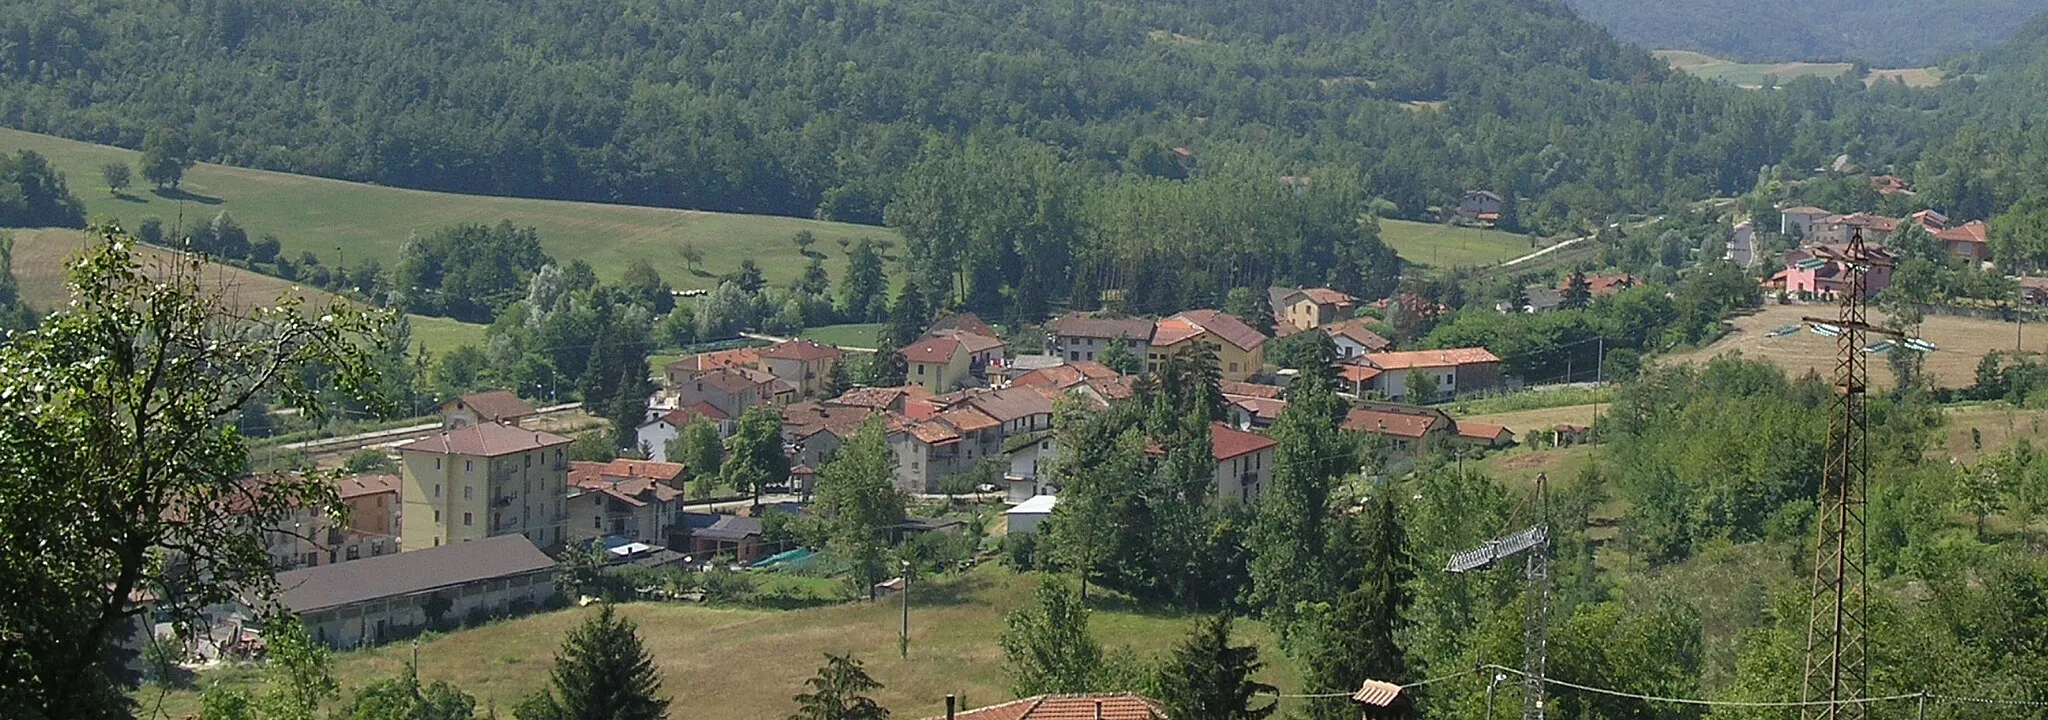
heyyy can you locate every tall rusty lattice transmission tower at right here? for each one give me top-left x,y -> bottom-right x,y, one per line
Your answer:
1802,231 -> 1901,720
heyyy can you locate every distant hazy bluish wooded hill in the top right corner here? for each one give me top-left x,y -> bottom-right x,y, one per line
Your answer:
1569,0 -> 2048,68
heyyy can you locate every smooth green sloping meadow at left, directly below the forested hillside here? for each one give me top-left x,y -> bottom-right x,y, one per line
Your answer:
0,129 -> 897,288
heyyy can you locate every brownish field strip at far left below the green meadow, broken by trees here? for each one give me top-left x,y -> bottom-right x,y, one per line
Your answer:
6,227 -> 485,352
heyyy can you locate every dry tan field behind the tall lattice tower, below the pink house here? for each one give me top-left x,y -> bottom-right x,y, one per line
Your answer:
1661,305 -> 2048,387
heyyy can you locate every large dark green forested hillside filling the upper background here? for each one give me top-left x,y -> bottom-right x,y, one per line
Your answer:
0,0 -> 1925,231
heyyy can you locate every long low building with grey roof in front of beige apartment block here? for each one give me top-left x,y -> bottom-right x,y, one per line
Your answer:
276,536 -> 555,648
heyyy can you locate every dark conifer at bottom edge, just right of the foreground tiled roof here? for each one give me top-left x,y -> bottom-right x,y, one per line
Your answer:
1159,614 -> 1278,720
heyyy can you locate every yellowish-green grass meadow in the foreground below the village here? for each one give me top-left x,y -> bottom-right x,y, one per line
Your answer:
141,567 -> 1300,718
